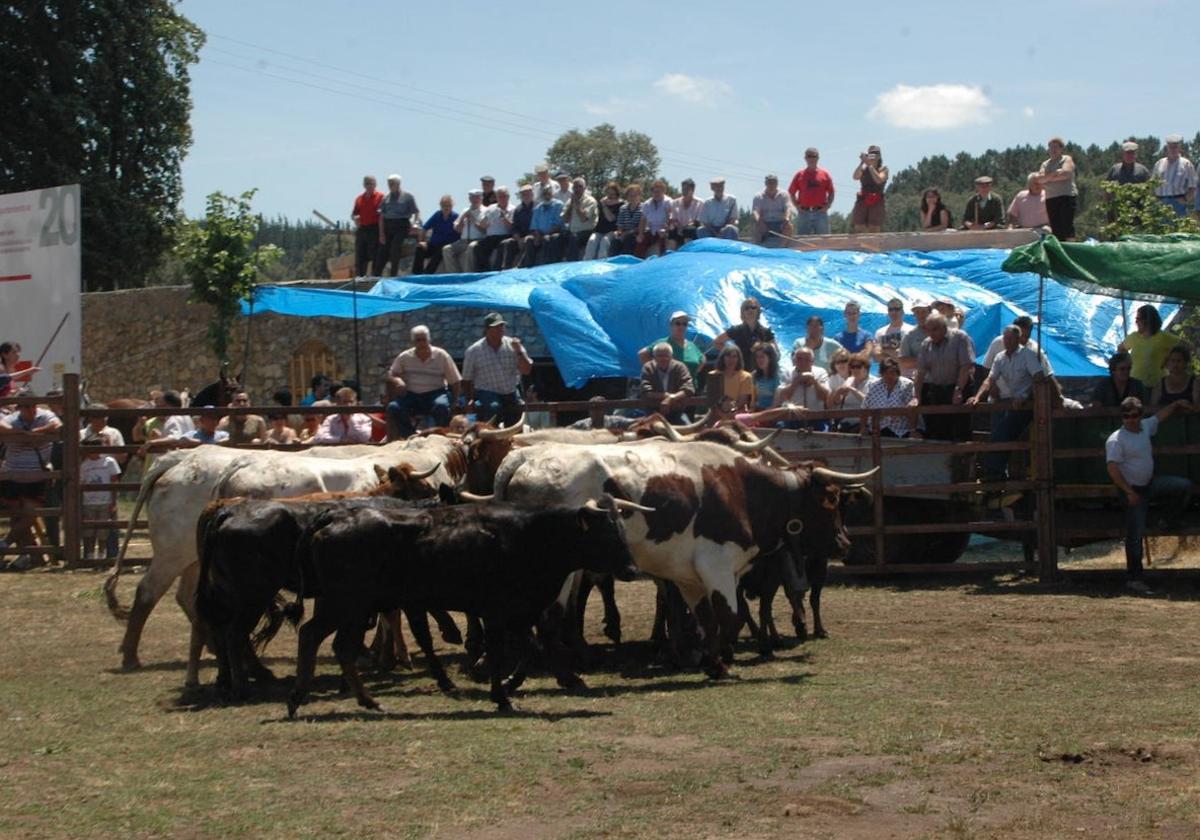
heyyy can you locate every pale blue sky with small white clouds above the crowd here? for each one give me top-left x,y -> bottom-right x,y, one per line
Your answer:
180,0 -> 1200,226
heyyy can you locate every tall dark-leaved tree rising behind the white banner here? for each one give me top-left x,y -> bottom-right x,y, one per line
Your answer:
0,0 -> 204,289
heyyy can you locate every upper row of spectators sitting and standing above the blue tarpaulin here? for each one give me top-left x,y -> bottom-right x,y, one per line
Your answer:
345,134 -> 1200,277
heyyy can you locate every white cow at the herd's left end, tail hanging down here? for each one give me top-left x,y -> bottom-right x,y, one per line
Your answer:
104,436 -> 461,685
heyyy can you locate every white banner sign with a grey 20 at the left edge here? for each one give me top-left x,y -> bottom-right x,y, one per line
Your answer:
0,184 -> 83,394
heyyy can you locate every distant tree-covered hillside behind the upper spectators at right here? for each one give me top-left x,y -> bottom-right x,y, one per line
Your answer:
884,133 -> 1200,238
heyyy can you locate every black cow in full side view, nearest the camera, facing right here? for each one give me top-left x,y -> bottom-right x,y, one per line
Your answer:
288,497 -> 636,715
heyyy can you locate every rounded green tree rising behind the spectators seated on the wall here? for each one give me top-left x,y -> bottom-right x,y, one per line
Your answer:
537,122 -> 662,194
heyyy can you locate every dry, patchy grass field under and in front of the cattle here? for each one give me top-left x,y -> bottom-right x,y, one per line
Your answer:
0,552 -> 1200,840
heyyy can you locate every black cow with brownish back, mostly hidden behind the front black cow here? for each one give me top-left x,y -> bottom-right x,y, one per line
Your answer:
196,493 -> 458,700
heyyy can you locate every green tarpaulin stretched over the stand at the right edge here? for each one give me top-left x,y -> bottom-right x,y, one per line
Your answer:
1001,234 -> 1200,302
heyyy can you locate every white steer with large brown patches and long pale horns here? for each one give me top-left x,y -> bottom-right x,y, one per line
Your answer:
484,440 -> 870,677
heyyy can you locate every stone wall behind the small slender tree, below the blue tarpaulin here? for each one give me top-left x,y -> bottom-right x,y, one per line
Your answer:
83,283 -> 548,403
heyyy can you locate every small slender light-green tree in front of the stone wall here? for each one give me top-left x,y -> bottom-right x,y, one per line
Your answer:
176,190 -> 281,364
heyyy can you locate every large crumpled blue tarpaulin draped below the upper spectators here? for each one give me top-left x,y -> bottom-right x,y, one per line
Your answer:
238,239 -> 1176,386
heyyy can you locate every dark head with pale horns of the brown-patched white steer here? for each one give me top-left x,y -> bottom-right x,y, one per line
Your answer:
780,467 -> 876,559
